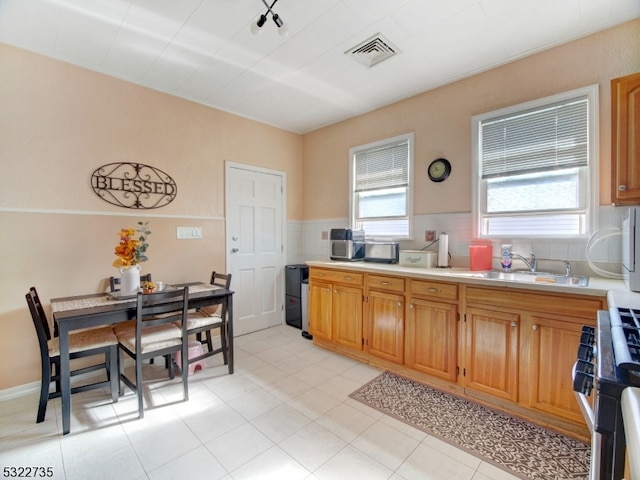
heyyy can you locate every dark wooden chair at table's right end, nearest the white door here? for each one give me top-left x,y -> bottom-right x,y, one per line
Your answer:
183,272 -> 231,365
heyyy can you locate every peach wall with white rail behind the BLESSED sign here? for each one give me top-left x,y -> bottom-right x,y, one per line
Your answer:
0,44 -> 302,390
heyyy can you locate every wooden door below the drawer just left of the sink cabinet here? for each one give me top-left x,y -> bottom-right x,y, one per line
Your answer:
405,298 -> 458,382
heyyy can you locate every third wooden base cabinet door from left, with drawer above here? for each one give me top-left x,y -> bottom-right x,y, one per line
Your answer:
364,274 -> 405,364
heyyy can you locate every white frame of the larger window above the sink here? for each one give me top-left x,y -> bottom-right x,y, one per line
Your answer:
471,84 -> 599,239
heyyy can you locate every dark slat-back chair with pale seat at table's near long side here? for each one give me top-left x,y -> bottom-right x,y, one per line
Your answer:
114,287 -> 189,418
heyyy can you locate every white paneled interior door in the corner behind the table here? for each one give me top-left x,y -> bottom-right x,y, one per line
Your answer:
225,162 -> 285,335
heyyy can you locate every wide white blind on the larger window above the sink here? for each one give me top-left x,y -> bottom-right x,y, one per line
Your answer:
481,96 -> 589,178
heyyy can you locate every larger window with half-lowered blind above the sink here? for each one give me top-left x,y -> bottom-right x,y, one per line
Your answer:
472,85 -> 598,238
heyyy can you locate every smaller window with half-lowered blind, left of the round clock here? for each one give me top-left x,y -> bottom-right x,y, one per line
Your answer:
349,133 -> 413,239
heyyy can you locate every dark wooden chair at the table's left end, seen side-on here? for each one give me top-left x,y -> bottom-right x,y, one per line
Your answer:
25,287 -> 119,423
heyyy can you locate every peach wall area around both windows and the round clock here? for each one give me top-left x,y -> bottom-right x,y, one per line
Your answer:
302,19 -> 640,220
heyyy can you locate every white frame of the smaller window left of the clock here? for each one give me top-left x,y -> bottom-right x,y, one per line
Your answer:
349,132 -> 414,240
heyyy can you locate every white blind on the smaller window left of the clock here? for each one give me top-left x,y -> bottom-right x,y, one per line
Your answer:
354,141 -> 409,193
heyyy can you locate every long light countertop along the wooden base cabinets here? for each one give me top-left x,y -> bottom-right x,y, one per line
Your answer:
306,260 -> 640,298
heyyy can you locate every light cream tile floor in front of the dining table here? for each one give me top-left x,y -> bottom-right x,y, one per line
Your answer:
0,326 -> 516,480
